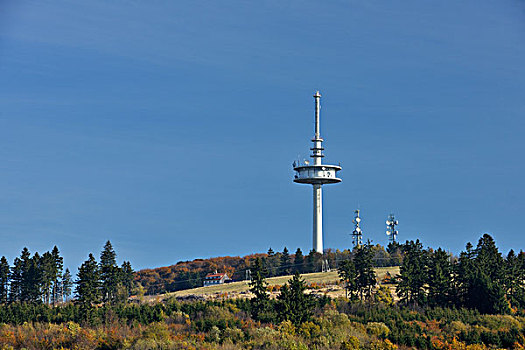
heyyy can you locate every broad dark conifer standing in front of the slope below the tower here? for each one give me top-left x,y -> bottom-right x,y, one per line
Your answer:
277,272 -> 314,326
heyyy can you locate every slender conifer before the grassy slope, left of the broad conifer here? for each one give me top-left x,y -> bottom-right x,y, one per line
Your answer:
250,258 -> 270,321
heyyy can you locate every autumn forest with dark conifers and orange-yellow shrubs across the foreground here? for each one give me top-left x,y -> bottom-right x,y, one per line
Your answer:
0,235 -> 525,350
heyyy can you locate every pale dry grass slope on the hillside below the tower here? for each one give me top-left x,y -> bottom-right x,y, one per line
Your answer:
151,266 -> 399,298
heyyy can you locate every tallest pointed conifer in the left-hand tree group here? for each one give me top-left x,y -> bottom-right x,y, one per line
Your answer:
100,241 -> 120,302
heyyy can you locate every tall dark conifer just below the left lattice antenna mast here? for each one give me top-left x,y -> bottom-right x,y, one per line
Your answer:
354,242 -> 377,299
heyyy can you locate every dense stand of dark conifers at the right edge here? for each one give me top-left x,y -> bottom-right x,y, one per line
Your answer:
396,234 -> 525,314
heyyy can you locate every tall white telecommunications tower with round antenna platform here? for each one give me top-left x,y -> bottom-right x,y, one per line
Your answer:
293,91 -> 342,253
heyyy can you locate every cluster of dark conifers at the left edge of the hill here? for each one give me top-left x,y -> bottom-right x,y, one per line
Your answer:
0,241 -> 134,307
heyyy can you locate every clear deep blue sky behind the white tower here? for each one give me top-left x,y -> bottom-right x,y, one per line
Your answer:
0,0 -> 525,272
